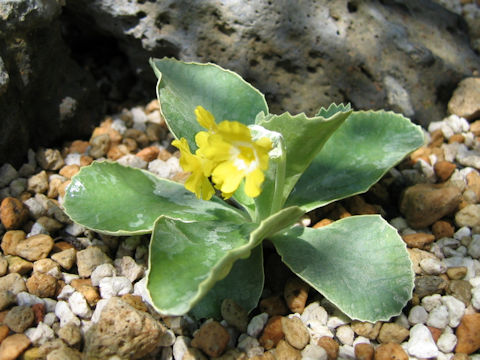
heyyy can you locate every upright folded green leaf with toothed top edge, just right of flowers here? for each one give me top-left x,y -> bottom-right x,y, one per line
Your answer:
256,111 -> 351,215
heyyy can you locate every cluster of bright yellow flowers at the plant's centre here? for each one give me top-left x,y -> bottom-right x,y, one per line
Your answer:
172,106 -> 272,200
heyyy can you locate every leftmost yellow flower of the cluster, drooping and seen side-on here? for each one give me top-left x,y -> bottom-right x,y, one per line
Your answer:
172,138 -> 215,200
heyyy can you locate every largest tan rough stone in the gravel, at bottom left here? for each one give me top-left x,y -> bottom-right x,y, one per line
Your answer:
84,297 -> 171,359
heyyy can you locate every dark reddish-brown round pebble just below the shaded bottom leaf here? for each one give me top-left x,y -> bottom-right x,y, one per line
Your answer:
191,321 -> 230,357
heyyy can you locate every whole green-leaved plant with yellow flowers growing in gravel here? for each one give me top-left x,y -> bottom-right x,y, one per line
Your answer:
64,58 -> 423,321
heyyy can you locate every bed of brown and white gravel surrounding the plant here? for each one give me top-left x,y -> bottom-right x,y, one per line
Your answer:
0,81 -> 480,360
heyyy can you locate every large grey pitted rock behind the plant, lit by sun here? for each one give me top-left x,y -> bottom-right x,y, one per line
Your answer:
67,0 -> 480,125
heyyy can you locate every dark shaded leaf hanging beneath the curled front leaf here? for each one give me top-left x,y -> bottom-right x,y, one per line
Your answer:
190,245 -> 264,319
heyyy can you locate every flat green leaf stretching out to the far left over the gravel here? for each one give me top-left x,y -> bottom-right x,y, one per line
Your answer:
64,161 -> 245,235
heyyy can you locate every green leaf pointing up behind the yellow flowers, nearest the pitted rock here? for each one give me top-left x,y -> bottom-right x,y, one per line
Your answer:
150,58 -> 268,149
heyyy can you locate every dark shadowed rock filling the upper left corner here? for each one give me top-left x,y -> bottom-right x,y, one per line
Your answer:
0,0 -> 100,165
